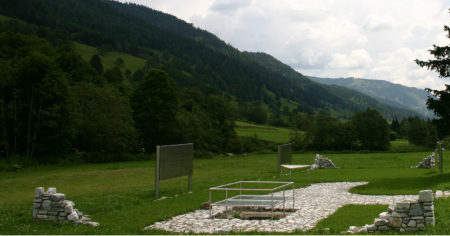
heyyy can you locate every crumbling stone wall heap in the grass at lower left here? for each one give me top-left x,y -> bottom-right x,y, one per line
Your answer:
33,187 -> 99,227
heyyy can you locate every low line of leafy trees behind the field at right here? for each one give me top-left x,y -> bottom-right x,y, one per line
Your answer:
288,108 -> 438,151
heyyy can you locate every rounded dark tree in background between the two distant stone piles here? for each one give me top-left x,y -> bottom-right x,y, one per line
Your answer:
352,108 -> 390,150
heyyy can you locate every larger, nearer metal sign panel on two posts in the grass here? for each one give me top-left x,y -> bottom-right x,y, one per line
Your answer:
155,143 -> 194,197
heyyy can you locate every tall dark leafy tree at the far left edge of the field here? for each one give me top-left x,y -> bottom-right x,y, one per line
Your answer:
0,32 -> 75,158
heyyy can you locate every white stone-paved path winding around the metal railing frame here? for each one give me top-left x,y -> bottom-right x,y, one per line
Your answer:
145,182 -> 418,234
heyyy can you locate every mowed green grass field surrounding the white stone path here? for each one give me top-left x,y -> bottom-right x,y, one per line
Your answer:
0,152 -> 450,234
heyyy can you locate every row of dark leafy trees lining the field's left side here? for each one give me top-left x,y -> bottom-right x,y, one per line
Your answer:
0,32 -> 248,165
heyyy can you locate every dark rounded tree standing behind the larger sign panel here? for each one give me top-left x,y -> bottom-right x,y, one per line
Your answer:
131,69 -> 179,152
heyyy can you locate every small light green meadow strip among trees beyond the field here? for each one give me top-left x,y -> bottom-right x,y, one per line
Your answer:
234,121 -> 289,144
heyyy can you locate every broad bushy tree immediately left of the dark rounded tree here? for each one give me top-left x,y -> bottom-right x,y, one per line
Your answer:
74,82 -> 138,152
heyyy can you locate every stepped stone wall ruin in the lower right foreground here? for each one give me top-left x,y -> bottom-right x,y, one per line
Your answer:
343,190 -> 435,233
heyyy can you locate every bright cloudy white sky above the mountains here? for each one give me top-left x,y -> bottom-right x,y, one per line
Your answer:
118,0 -> 450,90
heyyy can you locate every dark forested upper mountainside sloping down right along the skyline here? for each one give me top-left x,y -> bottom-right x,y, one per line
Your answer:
0,0 -> 426,117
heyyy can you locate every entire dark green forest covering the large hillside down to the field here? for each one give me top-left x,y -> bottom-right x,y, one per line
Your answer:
0,0 -> 437,168
